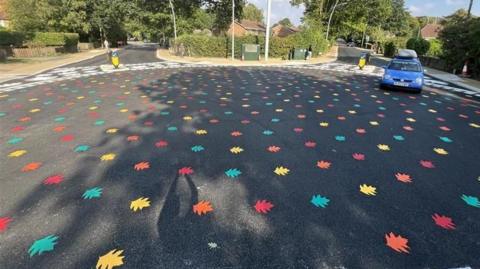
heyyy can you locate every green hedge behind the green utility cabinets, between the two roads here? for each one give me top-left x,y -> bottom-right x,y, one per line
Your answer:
173,29 -> 329,59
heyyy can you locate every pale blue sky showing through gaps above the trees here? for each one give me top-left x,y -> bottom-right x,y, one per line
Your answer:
248,0 -> 480,25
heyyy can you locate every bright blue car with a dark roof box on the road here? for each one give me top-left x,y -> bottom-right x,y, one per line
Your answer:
380,54 -> 424,93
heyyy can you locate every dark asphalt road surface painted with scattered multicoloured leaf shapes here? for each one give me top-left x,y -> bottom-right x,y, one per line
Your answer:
0,42 -> 480,269
